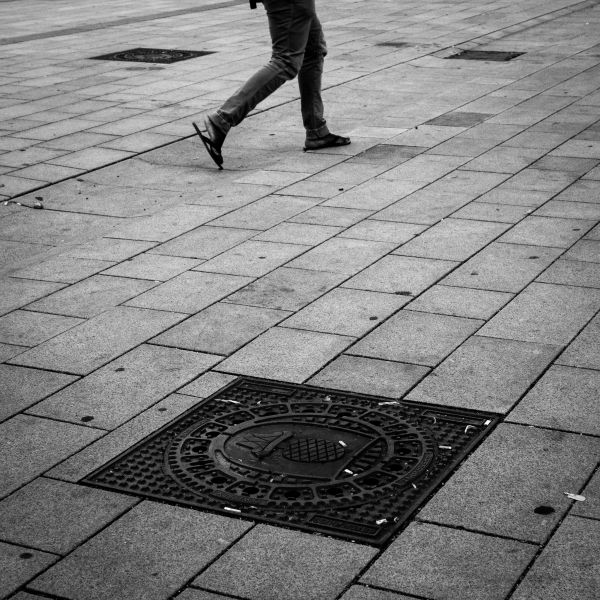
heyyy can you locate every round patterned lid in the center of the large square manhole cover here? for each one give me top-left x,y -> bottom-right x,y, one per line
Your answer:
164,401 -> 437,512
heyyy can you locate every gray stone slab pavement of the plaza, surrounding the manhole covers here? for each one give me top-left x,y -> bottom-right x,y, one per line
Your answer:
0,0 -> 600,600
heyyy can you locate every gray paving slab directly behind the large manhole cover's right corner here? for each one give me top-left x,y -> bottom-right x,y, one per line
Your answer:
408,335 -> 560,413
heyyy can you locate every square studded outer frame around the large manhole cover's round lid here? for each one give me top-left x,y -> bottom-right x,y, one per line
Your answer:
79,376 -> 502,547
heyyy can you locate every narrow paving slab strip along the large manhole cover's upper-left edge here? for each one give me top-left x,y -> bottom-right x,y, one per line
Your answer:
47,394 -> 198,483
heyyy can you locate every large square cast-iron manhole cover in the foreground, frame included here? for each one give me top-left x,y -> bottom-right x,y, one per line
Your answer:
83,378 -> 499,545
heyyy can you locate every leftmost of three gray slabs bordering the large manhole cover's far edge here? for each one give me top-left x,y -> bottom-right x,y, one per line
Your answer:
219,327 -> 354,383
